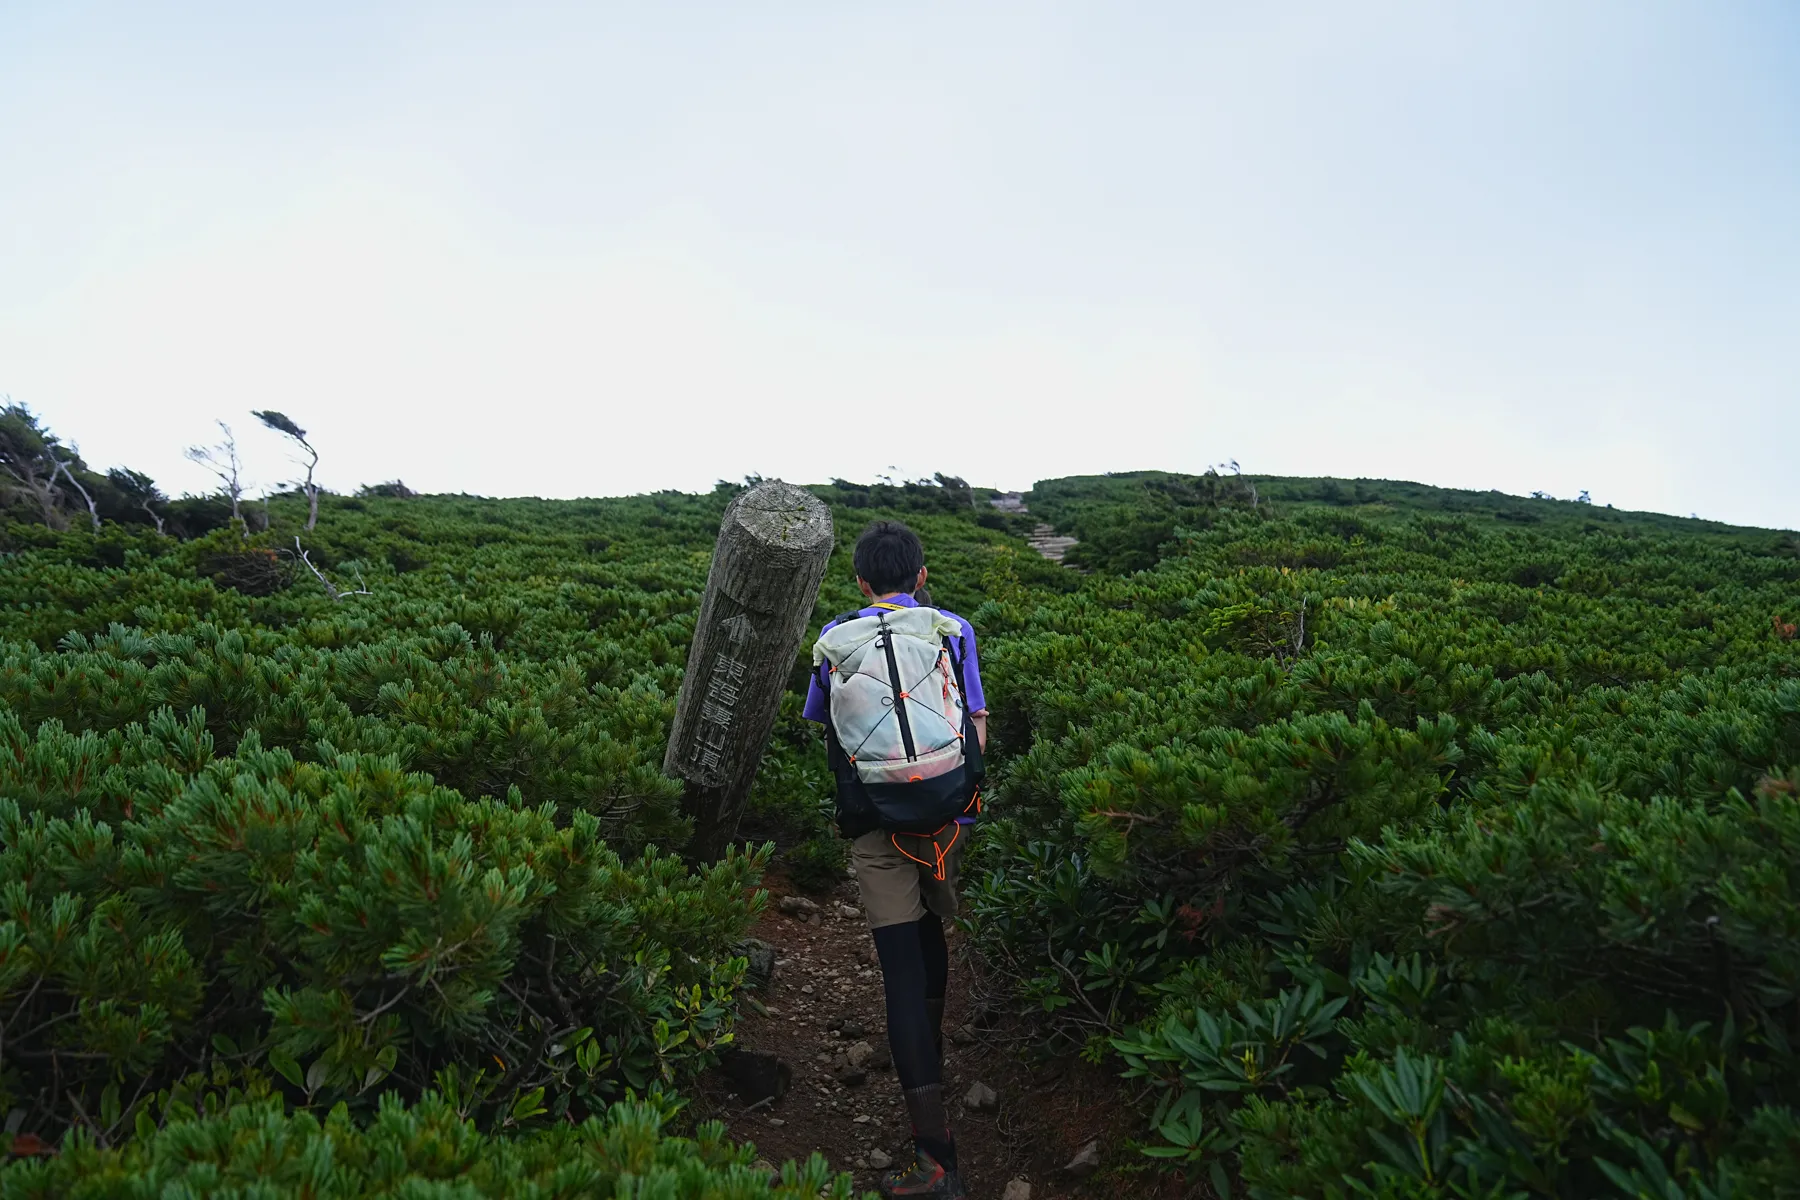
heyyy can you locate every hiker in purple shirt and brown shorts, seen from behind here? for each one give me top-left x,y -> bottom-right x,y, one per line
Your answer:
803,522 -> 988,1198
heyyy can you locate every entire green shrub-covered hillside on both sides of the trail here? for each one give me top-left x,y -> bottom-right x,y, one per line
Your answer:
0,444 -> 1800,1200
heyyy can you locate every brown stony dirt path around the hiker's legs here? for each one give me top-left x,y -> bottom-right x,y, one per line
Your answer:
695,876 -> 1152,1200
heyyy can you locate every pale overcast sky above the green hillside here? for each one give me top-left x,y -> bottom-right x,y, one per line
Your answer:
0,0 -> 1800,527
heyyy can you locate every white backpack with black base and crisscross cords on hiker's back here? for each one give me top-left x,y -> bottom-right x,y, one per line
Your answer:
812,608 -> 972,833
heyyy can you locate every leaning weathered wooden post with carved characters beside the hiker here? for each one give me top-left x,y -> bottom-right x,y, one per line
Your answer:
662,480 -> 832,860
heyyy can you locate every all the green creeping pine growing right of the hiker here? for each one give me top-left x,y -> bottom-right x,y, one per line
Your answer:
970,480 -> 1800,1200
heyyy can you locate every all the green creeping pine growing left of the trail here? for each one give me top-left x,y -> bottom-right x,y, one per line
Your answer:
0,488 -> 1053,1196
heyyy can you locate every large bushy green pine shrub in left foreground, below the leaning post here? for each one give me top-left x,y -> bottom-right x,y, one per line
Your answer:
0,737 -> 763,1144
